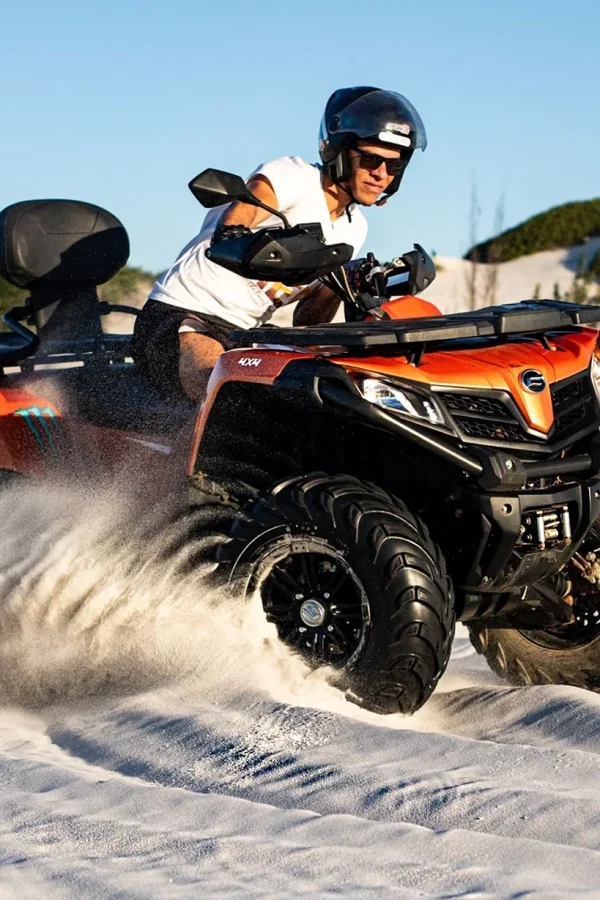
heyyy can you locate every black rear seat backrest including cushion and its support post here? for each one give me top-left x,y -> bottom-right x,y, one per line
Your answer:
0,200 -> 129,343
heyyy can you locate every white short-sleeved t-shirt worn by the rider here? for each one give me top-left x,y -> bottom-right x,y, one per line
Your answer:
150,156 -> 367,328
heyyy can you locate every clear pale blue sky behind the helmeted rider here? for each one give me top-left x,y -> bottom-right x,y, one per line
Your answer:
0,0 -> 600,271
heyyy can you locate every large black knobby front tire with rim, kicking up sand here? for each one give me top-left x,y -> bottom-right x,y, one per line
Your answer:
222,473 -> 454,713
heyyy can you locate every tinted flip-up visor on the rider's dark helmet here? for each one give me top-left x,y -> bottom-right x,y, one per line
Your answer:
329,91 -> 427,150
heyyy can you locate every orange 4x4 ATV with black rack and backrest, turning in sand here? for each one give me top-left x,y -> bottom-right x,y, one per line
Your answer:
0,170 -> 600,713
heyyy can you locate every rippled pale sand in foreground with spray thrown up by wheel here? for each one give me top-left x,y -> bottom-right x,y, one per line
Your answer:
0,488 -> 600,900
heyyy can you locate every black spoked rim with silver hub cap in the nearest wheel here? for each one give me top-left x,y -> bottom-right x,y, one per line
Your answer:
253,538 -> 370,668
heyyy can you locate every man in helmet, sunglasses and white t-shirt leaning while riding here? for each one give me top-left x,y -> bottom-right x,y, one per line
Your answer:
133,87 -> 427,401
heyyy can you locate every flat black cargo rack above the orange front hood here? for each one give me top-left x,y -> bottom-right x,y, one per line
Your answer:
229,300 -> 600,348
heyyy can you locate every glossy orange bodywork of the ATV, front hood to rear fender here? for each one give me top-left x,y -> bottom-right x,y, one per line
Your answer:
0,312 -> 598,475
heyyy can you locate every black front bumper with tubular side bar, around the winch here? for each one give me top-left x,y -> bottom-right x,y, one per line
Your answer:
276,360 -> 600,594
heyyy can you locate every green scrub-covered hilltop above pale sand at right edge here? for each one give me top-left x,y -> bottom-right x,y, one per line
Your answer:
464,198 -> 600,265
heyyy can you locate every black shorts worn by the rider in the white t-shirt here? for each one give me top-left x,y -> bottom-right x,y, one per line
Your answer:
131,300 -> 235,393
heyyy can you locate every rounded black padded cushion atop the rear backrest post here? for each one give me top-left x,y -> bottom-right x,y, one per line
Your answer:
0,200 -> 129,288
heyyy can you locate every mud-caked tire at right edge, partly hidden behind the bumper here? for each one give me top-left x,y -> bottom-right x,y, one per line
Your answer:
467,621 -> 600,692
